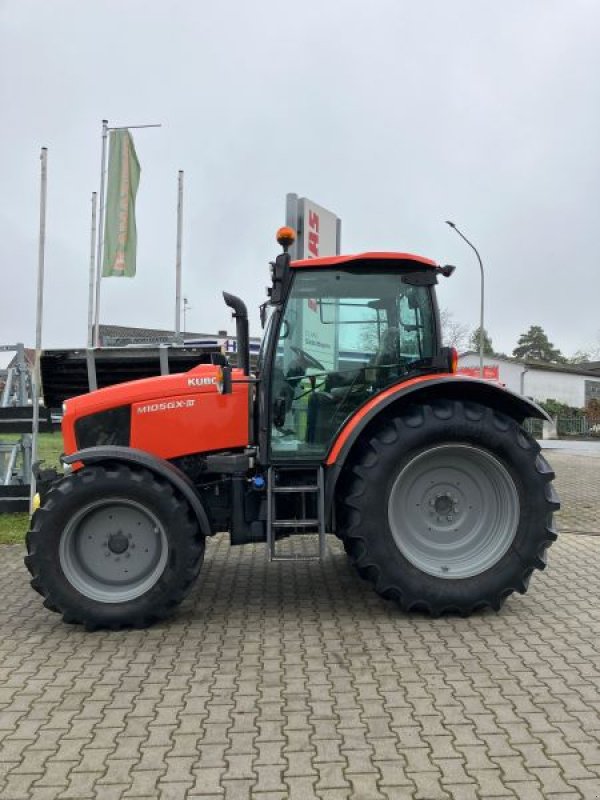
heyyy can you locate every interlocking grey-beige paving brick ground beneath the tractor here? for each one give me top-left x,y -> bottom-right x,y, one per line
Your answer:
0,453 -> 600,800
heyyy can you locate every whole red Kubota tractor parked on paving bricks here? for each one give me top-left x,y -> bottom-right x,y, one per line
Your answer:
26,228 -> 559,629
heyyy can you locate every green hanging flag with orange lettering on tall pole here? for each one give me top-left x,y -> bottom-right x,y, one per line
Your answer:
102,130 -> 140,278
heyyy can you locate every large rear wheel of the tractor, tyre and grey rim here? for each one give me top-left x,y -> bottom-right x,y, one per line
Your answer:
338,400 -> 559,615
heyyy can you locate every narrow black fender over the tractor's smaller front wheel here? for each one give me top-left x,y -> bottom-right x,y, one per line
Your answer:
62,446 -> 212,536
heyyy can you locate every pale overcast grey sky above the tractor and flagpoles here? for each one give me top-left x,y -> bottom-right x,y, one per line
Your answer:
0,0 -> 600,354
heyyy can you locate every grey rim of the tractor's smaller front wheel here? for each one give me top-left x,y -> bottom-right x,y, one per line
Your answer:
59,497 -> 169,603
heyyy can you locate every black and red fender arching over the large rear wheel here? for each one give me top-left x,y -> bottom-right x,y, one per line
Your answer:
325,374 -> 550,513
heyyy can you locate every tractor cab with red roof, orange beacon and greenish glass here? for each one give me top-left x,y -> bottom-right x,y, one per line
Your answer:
226,228 -> 453,463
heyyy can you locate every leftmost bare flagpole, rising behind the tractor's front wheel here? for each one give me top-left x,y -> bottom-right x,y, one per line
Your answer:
29,147 -> 48,513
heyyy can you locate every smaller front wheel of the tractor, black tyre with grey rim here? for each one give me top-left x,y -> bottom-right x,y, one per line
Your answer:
25,464 -> 204,629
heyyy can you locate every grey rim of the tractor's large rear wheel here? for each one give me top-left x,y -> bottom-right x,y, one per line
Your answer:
388,444 -> 520,580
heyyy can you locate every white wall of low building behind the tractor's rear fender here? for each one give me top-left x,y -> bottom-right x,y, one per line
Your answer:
458,351 -> 600,408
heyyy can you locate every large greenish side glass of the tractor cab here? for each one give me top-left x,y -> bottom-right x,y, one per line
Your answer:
271,269 -> 435,458
